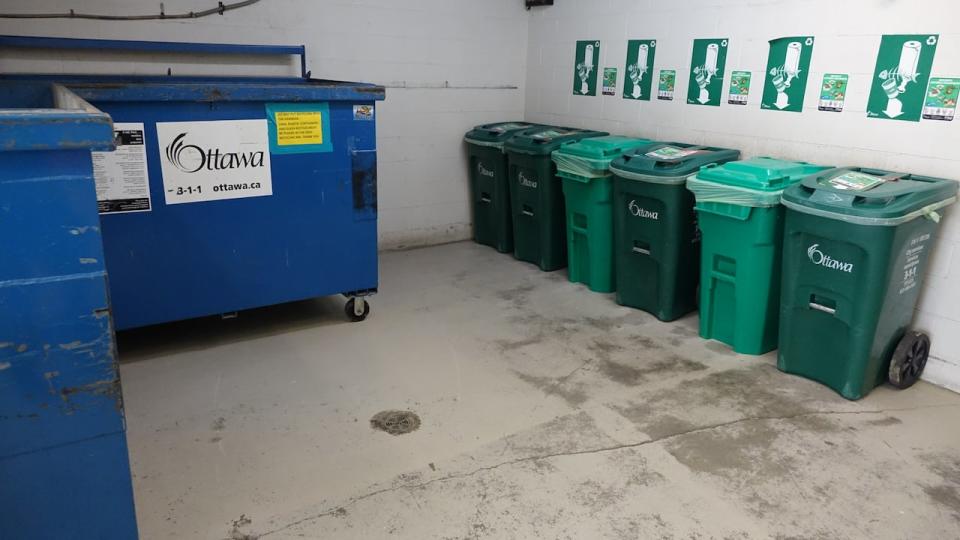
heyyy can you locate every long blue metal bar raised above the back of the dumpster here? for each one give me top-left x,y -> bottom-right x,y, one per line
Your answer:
0,36 -> 310,79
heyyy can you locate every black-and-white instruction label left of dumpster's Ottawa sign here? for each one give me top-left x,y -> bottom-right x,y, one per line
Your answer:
90,122 -> 150,214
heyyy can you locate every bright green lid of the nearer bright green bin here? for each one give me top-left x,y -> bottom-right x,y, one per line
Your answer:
697,157 -> 830,191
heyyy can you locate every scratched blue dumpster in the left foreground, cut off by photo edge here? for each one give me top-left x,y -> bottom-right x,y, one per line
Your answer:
0,83 -> 137,539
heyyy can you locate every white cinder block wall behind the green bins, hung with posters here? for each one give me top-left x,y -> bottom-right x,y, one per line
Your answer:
526,0 -> 960,390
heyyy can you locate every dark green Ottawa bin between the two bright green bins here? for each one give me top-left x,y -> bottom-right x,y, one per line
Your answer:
610,143 -> 740,321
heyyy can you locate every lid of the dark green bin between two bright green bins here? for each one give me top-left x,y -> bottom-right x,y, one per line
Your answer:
610,142 -> 740,179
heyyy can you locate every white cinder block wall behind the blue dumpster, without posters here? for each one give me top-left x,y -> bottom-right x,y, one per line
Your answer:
0,0 -> 528,249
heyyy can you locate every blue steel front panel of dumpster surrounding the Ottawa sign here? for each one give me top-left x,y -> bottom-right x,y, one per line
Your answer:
92,100 -> 377,329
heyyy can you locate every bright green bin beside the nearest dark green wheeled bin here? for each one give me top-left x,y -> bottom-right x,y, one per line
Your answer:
687,157 -> 828,354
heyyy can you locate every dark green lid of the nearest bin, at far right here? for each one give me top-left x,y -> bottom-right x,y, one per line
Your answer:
783,167 -> 957,225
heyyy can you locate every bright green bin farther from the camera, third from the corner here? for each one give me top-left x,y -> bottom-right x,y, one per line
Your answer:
553,135 -> 653,292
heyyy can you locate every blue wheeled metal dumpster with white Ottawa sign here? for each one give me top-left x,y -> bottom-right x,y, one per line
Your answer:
0,37 -> 384,329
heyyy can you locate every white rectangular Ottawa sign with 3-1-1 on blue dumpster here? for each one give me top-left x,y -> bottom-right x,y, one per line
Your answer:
157,119 -> 273,204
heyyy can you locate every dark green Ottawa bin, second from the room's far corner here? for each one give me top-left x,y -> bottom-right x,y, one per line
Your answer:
503,126 -> 607,272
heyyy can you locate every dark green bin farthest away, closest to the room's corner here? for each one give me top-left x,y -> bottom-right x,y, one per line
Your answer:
463,122 -> 536,253
